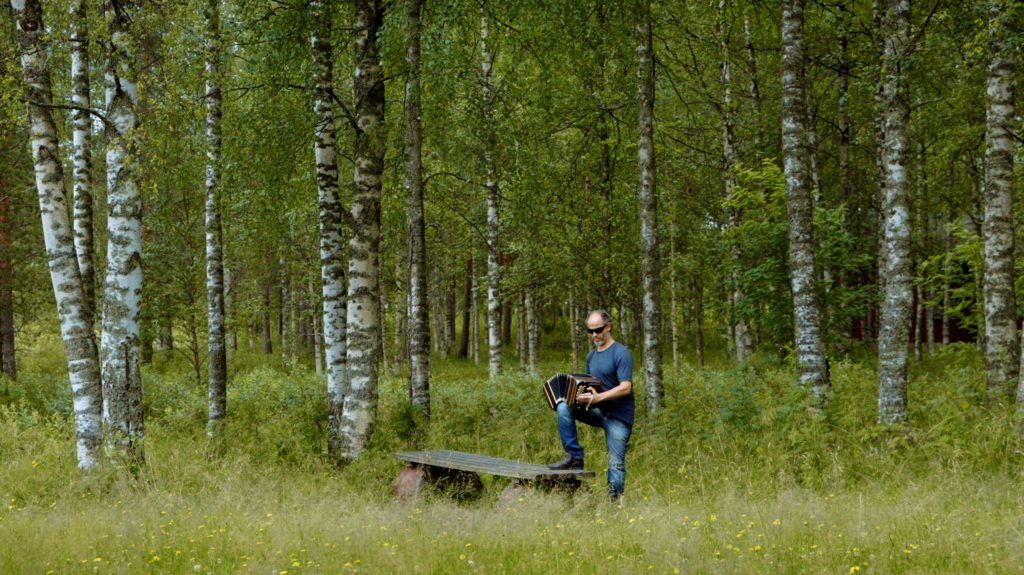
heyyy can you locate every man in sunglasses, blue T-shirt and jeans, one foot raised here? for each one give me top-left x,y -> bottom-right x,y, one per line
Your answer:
549,310 -> 635,500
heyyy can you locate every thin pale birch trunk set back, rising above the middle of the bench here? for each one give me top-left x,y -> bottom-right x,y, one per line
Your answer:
480,16 -> 502,380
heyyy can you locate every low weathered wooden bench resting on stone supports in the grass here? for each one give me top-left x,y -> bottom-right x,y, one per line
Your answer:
394,450 -> 594,497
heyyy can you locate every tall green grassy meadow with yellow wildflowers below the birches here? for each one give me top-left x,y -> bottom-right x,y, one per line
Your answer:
0,331 -> 1024,575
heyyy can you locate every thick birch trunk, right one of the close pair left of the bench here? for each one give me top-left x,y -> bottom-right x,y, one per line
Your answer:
340,0 -> 387,461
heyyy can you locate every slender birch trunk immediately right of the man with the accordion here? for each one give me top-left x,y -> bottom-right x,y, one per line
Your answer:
636,0 -> 665,415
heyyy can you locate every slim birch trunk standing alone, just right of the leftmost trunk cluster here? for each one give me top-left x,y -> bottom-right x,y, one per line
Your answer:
204,0 -> 227,437
